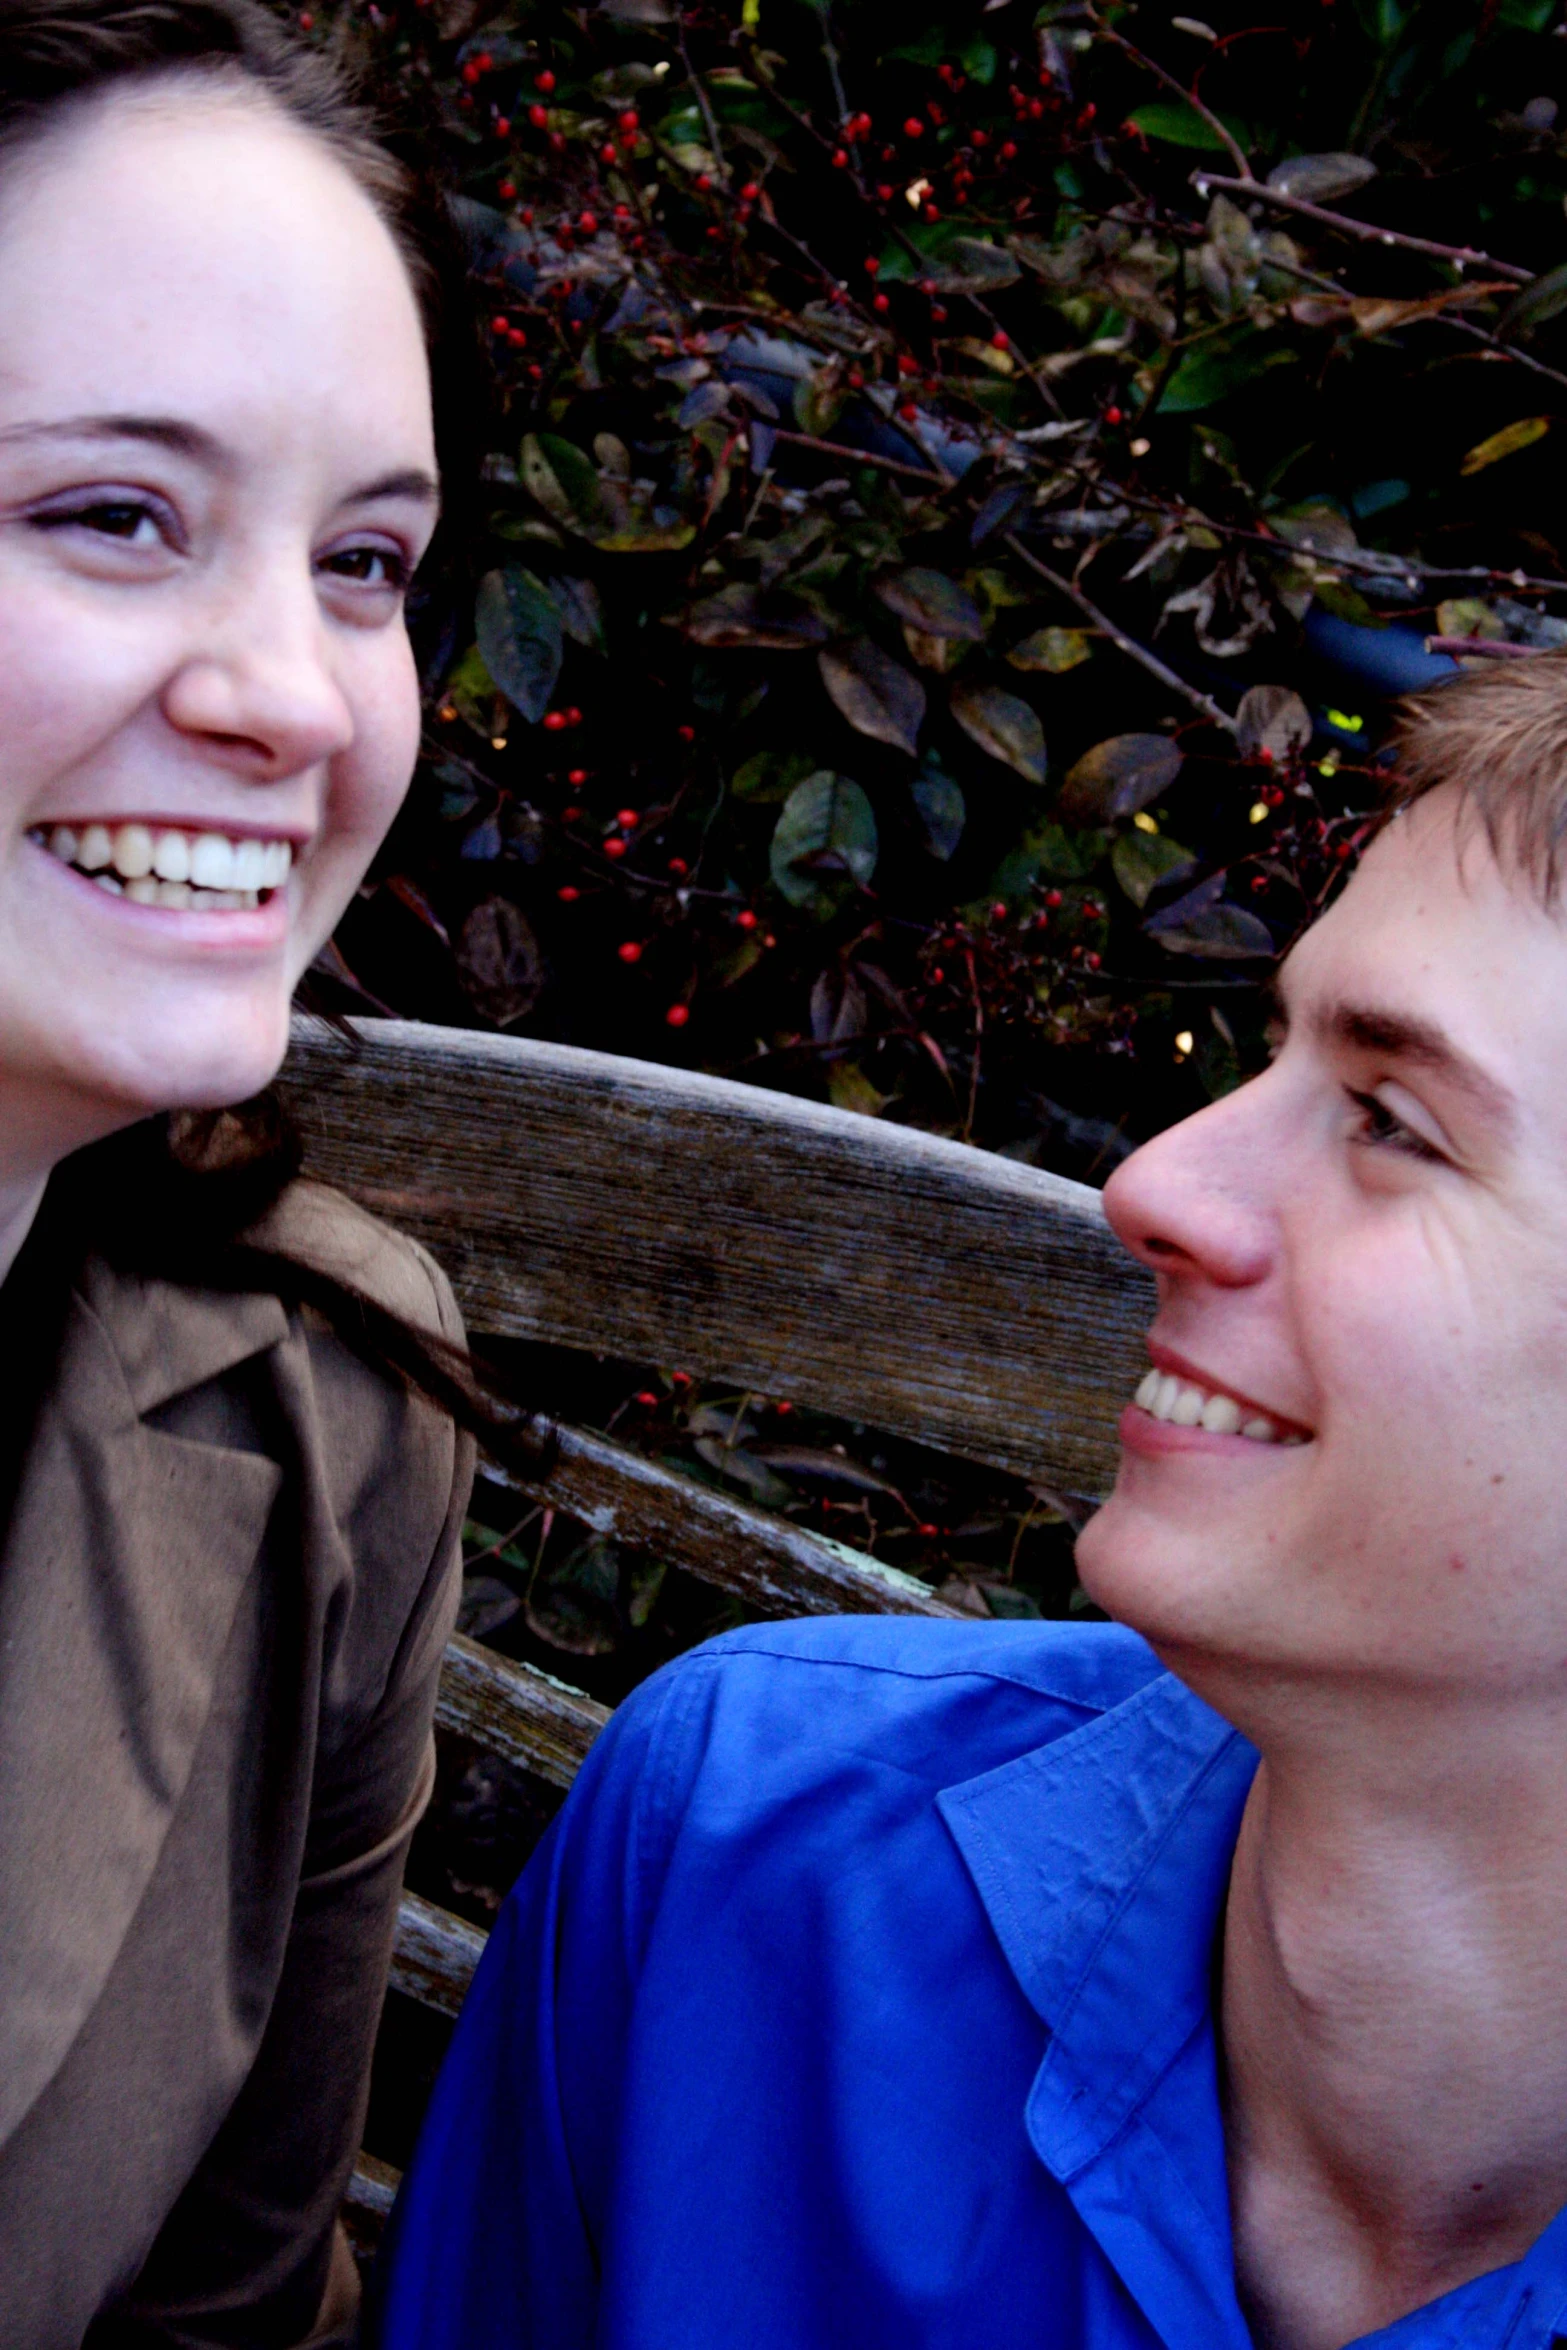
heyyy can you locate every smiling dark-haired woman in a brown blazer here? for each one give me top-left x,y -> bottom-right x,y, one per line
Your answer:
0,0 -> 514,2350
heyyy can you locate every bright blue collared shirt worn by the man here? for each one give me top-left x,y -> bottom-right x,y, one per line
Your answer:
381,1617 -> 1567,2350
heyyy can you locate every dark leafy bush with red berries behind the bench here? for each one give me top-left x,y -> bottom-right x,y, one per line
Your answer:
298,0 -> 1567,2152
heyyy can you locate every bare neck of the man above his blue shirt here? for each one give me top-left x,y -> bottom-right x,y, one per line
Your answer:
1217,1692 -> 1567,2350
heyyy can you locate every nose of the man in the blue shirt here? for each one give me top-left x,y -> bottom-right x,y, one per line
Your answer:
1104,1076 -> 1283,1288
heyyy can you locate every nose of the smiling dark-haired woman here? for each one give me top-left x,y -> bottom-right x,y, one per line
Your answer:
162,559 -> 355,783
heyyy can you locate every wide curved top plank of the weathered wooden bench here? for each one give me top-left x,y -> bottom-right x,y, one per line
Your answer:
282,1020 -> 1151,1495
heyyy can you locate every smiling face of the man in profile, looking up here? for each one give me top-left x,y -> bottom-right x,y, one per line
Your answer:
1078,792 -> 1567,1692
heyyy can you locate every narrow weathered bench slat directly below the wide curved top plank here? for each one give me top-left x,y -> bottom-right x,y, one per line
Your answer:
486,1429 -> 956,1617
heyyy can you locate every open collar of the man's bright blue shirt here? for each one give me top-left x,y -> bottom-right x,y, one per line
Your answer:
937,1673 -> 1567,2350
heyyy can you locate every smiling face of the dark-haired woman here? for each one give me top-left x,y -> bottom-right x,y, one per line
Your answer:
0,85 -> 435,1149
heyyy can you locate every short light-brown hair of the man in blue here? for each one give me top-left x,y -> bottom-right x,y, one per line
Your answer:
1386,649 -> 1567,907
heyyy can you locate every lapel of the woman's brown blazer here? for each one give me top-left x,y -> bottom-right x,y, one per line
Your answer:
0,1264 -> 287,2146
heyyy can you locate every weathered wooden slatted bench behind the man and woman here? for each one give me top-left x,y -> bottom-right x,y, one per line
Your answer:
282,1020 -> 1151,2242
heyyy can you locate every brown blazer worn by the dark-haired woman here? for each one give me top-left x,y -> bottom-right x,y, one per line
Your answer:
0,1184 -> 472,2350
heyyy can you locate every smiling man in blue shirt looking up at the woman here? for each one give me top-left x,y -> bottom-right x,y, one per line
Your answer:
371,658 -> 1567,2350
